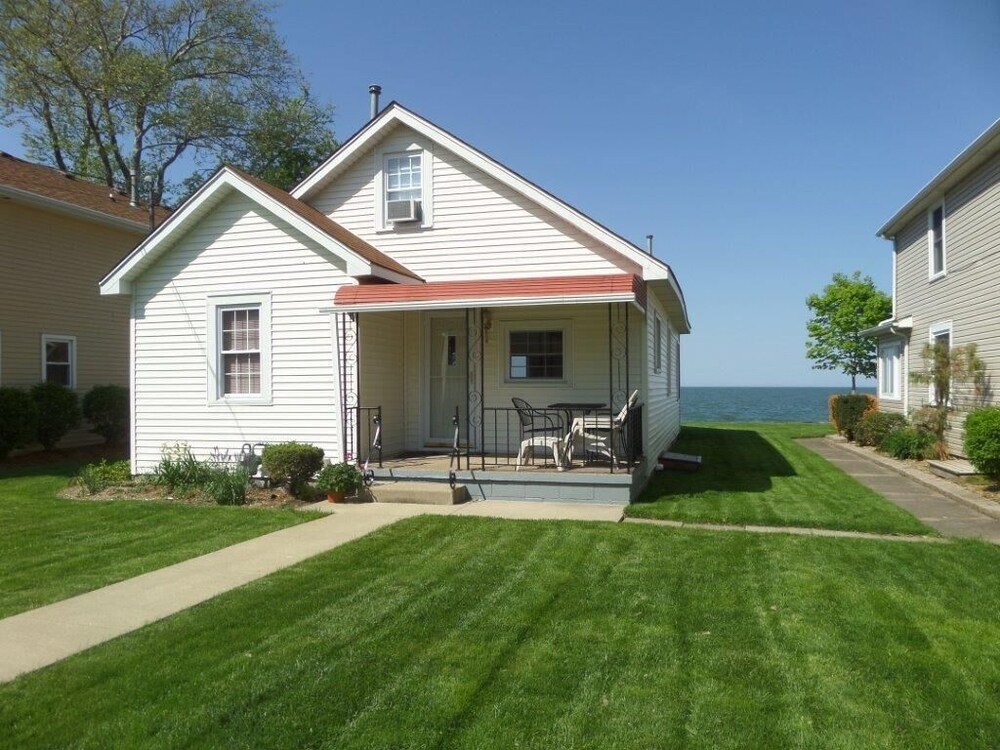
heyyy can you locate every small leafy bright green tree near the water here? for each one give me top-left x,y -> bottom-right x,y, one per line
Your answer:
806,271 -> 892,393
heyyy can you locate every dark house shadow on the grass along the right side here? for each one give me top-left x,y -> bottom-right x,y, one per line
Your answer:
636,427 -> 795,503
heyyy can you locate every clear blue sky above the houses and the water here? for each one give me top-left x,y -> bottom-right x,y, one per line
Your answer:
0,0 -> 1000,386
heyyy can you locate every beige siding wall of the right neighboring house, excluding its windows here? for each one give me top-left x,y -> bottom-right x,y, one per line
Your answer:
896,149 -> 1000,455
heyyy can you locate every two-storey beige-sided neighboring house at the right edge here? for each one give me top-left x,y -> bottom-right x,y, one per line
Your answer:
867,120 -> 1000,455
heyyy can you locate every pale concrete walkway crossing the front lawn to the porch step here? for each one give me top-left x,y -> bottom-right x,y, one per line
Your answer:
0,501 -> 623,682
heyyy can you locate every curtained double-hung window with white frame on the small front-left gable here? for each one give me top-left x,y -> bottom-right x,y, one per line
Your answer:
208,295 -> 271,403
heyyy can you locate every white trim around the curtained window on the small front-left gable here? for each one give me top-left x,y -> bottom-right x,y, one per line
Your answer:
205,292 -> 272,406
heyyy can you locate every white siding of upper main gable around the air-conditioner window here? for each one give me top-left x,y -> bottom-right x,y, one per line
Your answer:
309,126 -> 639,281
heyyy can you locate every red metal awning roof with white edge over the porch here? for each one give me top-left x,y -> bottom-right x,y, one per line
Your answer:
332,273 -> 646,312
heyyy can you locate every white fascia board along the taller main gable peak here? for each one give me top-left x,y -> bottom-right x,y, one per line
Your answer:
291,103 -> 670,280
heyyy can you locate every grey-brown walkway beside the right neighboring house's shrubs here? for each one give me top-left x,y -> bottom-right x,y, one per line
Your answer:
799,438 -> 1000,544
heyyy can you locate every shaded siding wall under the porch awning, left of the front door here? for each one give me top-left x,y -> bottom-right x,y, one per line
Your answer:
358,313 -> 409,456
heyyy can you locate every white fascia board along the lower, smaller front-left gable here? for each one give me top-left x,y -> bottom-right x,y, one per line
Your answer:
100,167 -> 376,295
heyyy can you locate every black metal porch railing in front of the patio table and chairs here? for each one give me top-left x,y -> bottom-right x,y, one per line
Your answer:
475,404 -> 643,473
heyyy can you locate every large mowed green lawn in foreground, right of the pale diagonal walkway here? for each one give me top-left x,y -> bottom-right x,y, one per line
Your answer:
0,517 -> 1000,750
